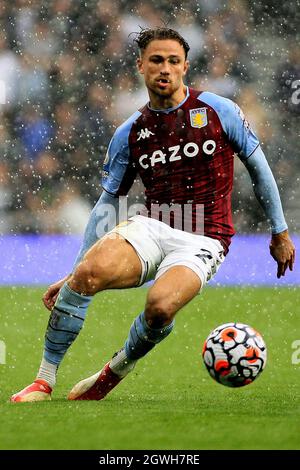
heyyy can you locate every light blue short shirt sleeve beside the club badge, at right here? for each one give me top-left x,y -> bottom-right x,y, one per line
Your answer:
198,91 -> 259,160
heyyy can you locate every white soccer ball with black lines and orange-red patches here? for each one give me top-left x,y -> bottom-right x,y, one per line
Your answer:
202,323 -> 267,387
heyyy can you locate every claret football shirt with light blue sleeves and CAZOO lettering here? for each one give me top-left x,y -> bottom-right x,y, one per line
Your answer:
102,88 -> 259,251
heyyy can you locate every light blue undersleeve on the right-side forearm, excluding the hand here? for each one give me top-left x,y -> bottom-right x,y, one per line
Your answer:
243,146 -> 288,234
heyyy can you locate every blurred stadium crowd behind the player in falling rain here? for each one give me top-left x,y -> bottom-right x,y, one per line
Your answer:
0,0 -> 300,234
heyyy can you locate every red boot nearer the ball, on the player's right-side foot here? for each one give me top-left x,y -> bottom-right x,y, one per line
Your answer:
68,362 -> 122,400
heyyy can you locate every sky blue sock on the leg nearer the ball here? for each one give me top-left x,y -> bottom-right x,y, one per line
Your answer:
125,312 -> 175,359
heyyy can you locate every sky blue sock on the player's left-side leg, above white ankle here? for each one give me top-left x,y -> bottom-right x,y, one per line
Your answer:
44,282 -> 92,365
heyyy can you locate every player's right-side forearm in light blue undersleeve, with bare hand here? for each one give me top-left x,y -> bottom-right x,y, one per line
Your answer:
243,147 -> 295,278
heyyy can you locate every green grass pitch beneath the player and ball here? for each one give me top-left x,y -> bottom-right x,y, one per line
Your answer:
0,288 -> 300,450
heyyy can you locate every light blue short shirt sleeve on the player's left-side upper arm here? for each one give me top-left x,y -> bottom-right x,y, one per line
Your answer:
102,111 -> 141,195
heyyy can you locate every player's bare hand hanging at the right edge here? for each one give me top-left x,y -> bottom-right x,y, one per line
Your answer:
270,230 -> 295,278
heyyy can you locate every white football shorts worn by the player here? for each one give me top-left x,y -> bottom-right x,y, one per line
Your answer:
108,215 -> 225,288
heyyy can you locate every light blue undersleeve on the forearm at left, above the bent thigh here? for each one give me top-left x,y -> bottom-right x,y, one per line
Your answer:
73,191 -> 119,270
